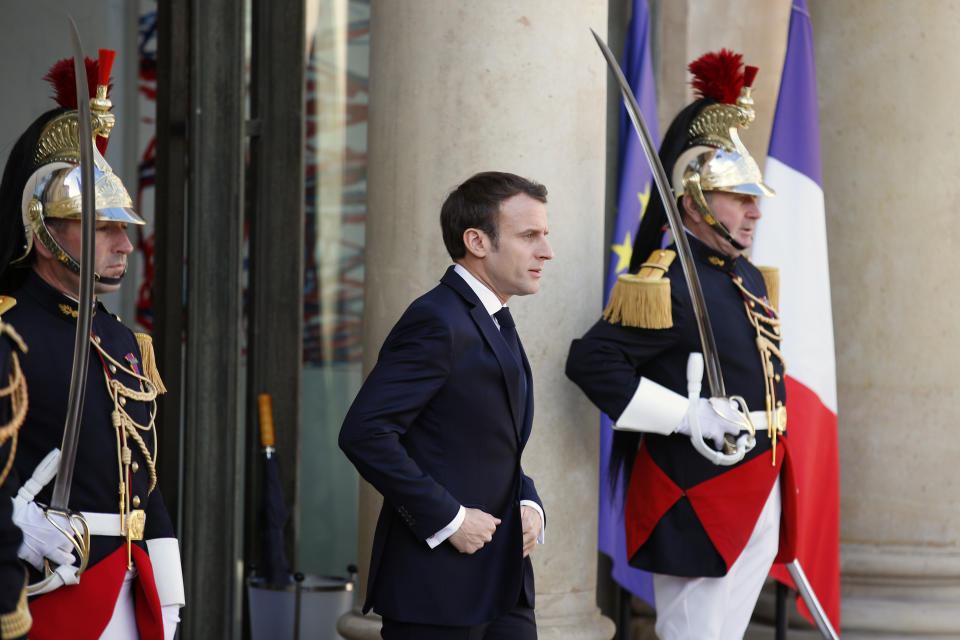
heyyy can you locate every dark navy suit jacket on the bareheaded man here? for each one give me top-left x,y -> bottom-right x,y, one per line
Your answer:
340,267 -> 541,626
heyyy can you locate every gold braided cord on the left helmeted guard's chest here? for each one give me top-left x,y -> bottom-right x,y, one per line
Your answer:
90,339 -> 157,566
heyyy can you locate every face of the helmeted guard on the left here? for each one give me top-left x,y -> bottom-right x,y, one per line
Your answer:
49,220 -> 133,296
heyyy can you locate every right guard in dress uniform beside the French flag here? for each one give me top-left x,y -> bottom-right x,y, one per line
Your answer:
567,50 -> 795,640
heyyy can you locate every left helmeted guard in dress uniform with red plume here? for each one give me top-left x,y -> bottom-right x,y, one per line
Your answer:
0,50 -> 185,640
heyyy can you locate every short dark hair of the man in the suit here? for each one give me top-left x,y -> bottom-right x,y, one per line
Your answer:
440,171 -> 547,261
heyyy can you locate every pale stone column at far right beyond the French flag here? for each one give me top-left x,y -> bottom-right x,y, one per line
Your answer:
810,0 -> 960,639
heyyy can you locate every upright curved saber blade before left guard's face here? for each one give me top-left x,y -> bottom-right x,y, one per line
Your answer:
50,16 -> 96,512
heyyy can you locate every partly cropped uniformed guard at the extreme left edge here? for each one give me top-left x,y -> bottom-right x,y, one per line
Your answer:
0,304 -> 31,640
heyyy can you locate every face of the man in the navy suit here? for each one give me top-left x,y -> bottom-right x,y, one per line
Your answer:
483,193 -> 553,303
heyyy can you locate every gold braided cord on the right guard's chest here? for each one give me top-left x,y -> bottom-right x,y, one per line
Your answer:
732,276 -> 787,465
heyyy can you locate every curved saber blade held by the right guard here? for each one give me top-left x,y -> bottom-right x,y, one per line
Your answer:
590,29 -> 727,398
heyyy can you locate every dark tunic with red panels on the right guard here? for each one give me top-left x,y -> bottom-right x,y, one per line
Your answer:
567,234 -> 792,576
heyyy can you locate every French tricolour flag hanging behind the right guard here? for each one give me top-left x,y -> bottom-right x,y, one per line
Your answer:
751,0 -> 840,629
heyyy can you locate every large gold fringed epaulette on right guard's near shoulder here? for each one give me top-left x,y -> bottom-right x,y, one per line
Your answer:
603,249 -> 677,329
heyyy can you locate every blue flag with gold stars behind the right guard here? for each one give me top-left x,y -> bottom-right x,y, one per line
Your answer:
598,0 -> 660,605
